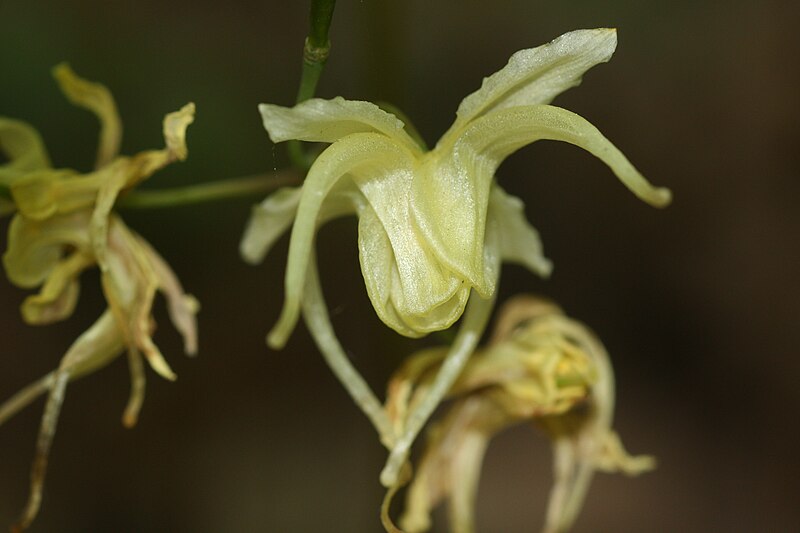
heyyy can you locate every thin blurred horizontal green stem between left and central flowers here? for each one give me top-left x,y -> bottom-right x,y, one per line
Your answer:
117,171 -> 301,209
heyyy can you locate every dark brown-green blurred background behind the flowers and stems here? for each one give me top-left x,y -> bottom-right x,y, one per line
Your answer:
0,0 -> 800,532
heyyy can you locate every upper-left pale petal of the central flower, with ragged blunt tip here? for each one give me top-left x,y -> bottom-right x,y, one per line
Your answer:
258,97 -> 419,151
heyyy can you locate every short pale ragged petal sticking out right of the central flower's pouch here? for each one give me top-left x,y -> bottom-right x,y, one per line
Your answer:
488,184 -> 553,278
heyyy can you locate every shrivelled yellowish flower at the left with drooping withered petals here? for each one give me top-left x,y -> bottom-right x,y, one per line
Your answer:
0,65 -> 198,529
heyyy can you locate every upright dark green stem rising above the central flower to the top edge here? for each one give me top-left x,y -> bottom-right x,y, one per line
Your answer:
287,0 -> 336,170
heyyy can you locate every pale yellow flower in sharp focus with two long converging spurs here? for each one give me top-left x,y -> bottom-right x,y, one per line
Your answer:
241,29 -> 670,486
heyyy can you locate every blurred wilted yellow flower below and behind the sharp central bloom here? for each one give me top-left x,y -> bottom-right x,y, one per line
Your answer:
387,296 -> 654,533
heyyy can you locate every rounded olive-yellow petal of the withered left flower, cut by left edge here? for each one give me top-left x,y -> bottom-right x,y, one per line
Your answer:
0,117 -> 50,186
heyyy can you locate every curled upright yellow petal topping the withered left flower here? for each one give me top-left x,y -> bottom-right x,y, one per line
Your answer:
53,63 -> 122,168
